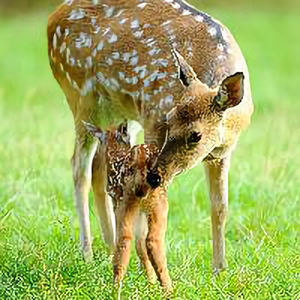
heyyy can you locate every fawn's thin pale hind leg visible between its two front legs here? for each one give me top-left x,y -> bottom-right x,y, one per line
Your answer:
135,211 -> 156,283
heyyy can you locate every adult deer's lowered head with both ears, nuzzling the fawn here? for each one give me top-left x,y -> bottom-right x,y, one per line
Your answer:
149,51 -> 244,185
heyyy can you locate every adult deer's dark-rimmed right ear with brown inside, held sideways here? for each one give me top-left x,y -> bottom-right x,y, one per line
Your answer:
214,72 -> 245,111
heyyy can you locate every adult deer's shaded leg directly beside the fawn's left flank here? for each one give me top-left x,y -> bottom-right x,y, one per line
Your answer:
92,145 -> 116,251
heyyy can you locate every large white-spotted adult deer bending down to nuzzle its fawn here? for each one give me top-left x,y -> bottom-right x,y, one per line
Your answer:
48,0 -> 253,270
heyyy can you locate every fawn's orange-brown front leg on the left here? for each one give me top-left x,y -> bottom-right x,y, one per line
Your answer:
113,196 -> 138,295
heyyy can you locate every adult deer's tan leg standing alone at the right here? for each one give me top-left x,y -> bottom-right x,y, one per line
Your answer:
205,157 -> 230,274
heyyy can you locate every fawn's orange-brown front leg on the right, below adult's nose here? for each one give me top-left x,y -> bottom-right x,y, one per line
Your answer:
146,187 -> 172,292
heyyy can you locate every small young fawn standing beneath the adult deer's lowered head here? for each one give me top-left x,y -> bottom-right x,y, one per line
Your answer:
84,123 -> 171,292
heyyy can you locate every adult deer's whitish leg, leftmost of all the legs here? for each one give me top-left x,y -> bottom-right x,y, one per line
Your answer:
72,136 -> 98,261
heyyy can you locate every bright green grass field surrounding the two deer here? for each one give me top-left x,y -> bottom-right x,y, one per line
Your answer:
0,5 -> 300,300
